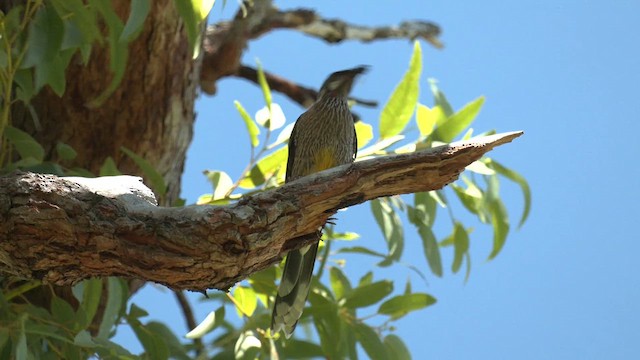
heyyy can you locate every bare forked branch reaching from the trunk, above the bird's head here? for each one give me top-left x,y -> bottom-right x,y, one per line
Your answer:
200,0 -> 442,97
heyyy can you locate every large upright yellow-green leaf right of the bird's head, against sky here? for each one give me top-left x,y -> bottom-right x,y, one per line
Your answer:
380,41 -> 422,139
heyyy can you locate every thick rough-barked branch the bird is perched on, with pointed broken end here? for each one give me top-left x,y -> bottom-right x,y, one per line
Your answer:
0,132 -> 522,291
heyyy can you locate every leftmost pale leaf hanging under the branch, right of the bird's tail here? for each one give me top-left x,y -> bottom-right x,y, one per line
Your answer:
370,199 -> 404,266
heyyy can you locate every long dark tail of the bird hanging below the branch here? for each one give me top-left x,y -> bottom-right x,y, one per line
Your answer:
271,243 -> 318,339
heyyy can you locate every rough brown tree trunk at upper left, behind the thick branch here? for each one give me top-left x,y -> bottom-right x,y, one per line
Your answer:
13,0 -> 199,202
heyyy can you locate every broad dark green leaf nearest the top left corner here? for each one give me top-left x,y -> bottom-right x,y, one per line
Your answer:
21,4 -> 64,68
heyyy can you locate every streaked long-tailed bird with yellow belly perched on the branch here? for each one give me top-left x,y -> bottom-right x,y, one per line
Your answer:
271,66 -> 368,339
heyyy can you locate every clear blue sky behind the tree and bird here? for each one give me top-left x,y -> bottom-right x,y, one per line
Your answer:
118,0 -> 640,359
